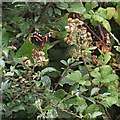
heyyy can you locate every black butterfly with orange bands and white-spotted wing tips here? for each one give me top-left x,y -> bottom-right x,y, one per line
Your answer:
29,31 -> 52,48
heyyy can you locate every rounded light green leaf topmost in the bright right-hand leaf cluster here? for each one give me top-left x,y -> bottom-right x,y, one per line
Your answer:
100,65 -> 112,78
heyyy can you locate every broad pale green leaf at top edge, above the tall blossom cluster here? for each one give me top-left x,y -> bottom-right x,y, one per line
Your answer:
67,3 -> 86,14
